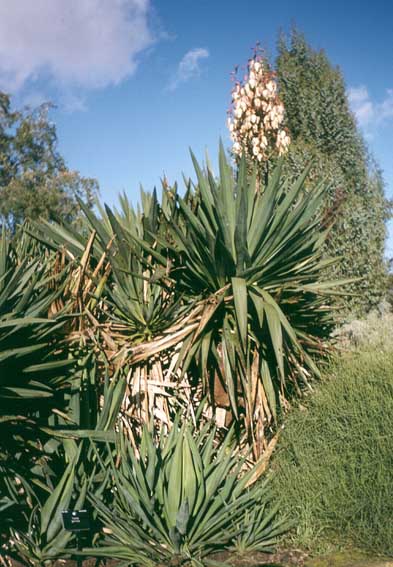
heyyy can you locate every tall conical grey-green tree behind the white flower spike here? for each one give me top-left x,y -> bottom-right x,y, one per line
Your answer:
276,29 -> 389,313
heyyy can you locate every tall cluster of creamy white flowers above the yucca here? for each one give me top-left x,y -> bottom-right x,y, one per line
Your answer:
228,55 -> 291,162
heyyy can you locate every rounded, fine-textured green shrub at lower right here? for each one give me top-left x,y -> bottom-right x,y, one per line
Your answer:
273,350 -> 393,555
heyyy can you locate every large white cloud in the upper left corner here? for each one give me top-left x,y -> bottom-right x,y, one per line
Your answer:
0,0 -> 154,96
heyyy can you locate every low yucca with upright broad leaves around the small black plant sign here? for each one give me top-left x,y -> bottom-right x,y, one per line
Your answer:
5,365 -> 126,567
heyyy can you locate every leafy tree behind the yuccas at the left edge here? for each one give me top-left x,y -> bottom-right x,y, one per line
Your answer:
0,92 -> 98,232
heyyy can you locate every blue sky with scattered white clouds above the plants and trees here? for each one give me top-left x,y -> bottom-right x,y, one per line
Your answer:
0,0 -> 393,256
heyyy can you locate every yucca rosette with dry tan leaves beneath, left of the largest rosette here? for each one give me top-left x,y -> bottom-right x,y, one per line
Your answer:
28,188 -> 197,430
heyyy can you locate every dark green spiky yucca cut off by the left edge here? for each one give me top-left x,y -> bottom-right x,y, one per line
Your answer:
0,225 -> 75,539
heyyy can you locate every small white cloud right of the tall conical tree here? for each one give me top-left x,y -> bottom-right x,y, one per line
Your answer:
348,85 -> 393,129
